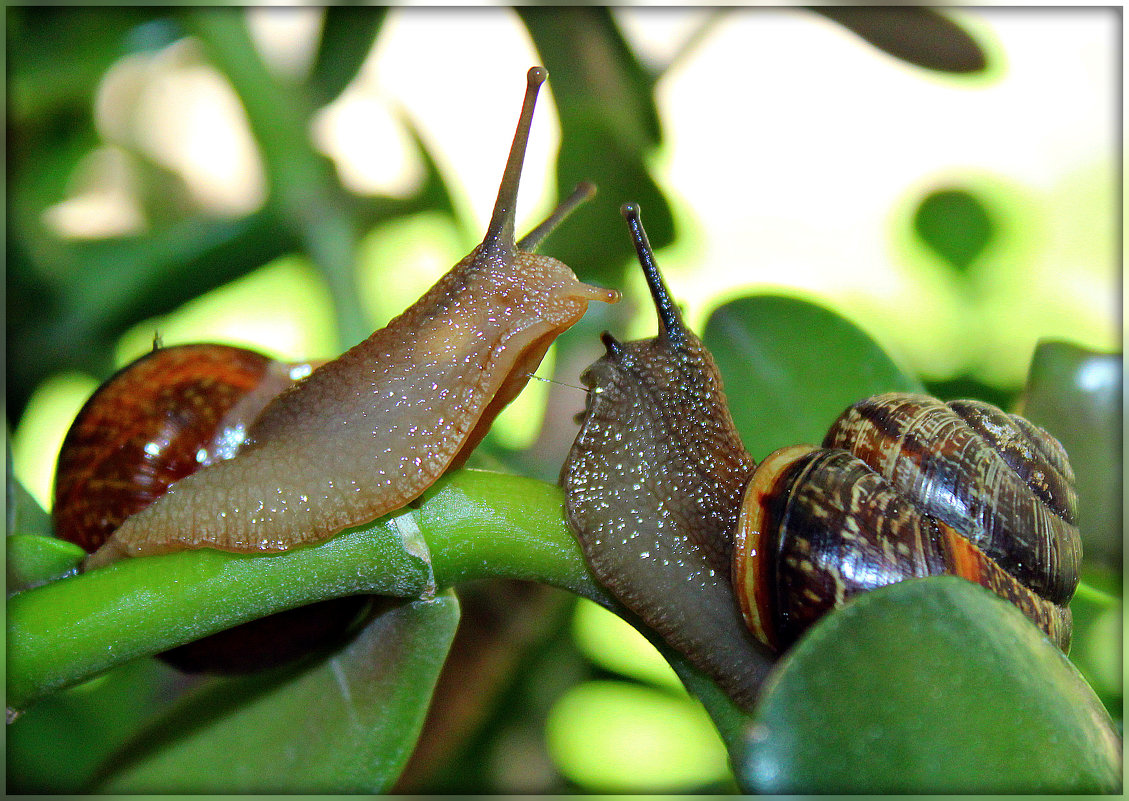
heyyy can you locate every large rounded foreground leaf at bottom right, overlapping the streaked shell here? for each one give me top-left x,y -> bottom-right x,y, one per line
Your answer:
738,576 -> 1121,793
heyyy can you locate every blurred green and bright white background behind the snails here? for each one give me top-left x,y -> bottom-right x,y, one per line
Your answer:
6,7 -> 1122,792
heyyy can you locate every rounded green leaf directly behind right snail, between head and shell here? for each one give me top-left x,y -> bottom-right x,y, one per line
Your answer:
702,295 -> 922,461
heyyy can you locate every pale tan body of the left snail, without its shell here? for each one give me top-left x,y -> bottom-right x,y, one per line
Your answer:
87,68 -> 619,568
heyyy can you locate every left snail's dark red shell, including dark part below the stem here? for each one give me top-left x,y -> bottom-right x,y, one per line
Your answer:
53,343 -> 369,673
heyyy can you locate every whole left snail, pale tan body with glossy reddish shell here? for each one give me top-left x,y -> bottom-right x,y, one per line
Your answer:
54,67 -> 619,668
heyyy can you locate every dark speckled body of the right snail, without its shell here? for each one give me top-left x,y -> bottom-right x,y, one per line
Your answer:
561,207 -> 769,706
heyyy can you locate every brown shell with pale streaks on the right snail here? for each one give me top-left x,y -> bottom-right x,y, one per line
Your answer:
734,393 -> 1082,651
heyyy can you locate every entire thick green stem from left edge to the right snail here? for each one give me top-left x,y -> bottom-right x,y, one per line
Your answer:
8,470 -> 611,709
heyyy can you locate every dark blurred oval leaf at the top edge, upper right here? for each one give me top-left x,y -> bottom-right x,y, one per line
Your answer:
812,6 -> 988,73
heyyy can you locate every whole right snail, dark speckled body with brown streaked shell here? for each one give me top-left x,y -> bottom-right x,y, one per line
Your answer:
561,204 -> 1080,708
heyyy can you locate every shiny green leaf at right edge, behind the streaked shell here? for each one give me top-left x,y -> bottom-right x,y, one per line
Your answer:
1019,341 -> 1124,574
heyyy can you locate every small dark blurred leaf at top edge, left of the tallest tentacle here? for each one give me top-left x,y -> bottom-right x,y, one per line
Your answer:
306,6 -> 388,108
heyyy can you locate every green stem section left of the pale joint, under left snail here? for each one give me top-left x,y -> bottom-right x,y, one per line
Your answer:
8,503 -> 434,709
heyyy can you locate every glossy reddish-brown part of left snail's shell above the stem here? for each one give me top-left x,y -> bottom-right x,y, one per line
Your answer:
53,343 -> 313,554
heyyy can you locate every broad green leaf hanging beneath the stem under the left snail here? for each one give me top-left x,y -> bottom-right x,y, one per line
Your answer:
98,593 -> 458,793
